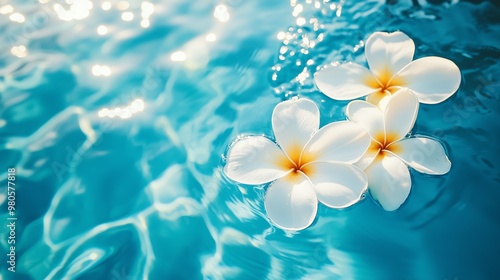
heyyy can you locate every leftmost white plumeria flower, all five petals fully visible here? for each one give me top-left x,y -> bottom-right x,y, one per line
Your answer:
224,99 -> 371,230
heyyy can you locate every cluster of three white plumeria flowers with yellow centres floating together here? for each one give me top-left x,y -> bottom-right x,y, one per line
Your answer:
224,32 -> 461,230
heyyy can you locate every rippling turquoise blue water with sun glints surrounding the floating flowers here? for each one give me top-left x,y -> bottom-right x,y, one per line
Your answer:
0,0 -> 500,280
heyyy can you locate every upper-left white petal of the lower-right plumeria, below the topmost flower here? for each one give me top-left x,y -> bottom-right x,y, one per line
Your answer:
346,100 -> 385,139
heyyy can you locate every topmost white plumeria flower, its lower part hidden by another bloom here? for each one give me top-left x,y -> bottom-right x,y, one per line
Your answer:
314,31 -> 461,105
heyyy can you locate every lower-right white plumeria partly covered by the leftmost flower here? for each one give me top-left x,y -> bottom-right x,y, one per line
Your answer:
347,89 -> 451,211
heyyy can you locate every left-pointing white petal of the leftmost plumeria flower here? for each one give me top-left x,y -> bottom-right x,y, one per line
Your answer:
224,136 -> 289,185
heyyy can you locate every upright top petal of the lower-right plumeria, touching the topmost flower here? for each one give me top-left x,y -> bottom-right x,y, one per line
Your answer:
384,89 -> 419,144
